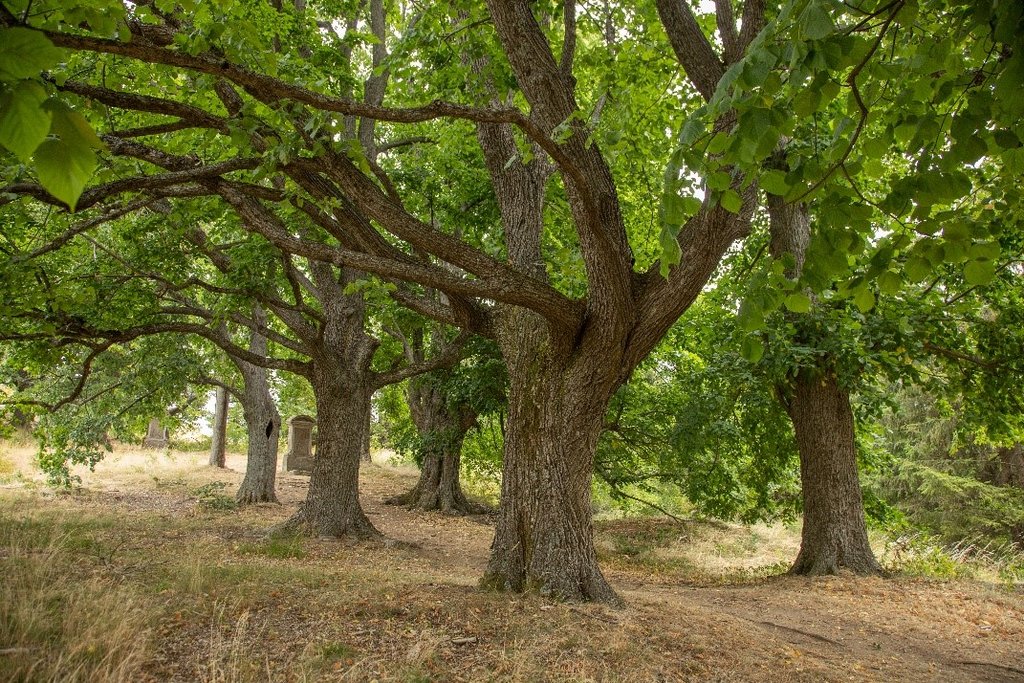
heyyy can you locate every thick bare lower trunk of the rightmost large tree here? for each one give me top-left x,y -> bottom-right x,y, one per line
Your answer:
786,373 -> 882,575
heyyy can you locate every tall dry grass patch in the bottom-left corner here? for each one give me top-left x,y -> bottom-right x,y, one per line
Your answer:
0,517 -> 151,683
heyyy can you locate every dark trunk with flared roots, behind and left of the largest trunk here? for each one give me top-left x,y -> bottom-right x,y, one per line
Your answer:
386,379 -> 483,515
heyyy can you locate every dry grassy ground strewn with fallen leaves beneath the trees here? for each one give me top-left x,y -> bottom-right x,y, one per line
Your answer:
0,443 -> 1024,682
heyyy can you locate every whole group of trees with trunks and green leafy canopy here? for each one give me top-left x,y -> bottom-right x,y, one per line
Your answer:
0,0 -> 1024,601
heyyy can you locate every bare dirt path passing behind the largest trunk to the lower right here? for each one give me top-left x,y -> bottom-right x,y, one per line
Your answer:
333,462 -> 1024,681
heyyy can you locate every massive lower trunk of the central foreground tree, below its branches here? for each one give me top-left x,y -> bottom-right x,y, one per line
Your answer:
481,309 -> 618,603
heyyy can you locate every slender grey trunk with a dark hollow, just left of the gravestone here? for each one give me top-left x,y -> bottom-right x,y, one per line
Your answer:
234,360 -> 281,505
